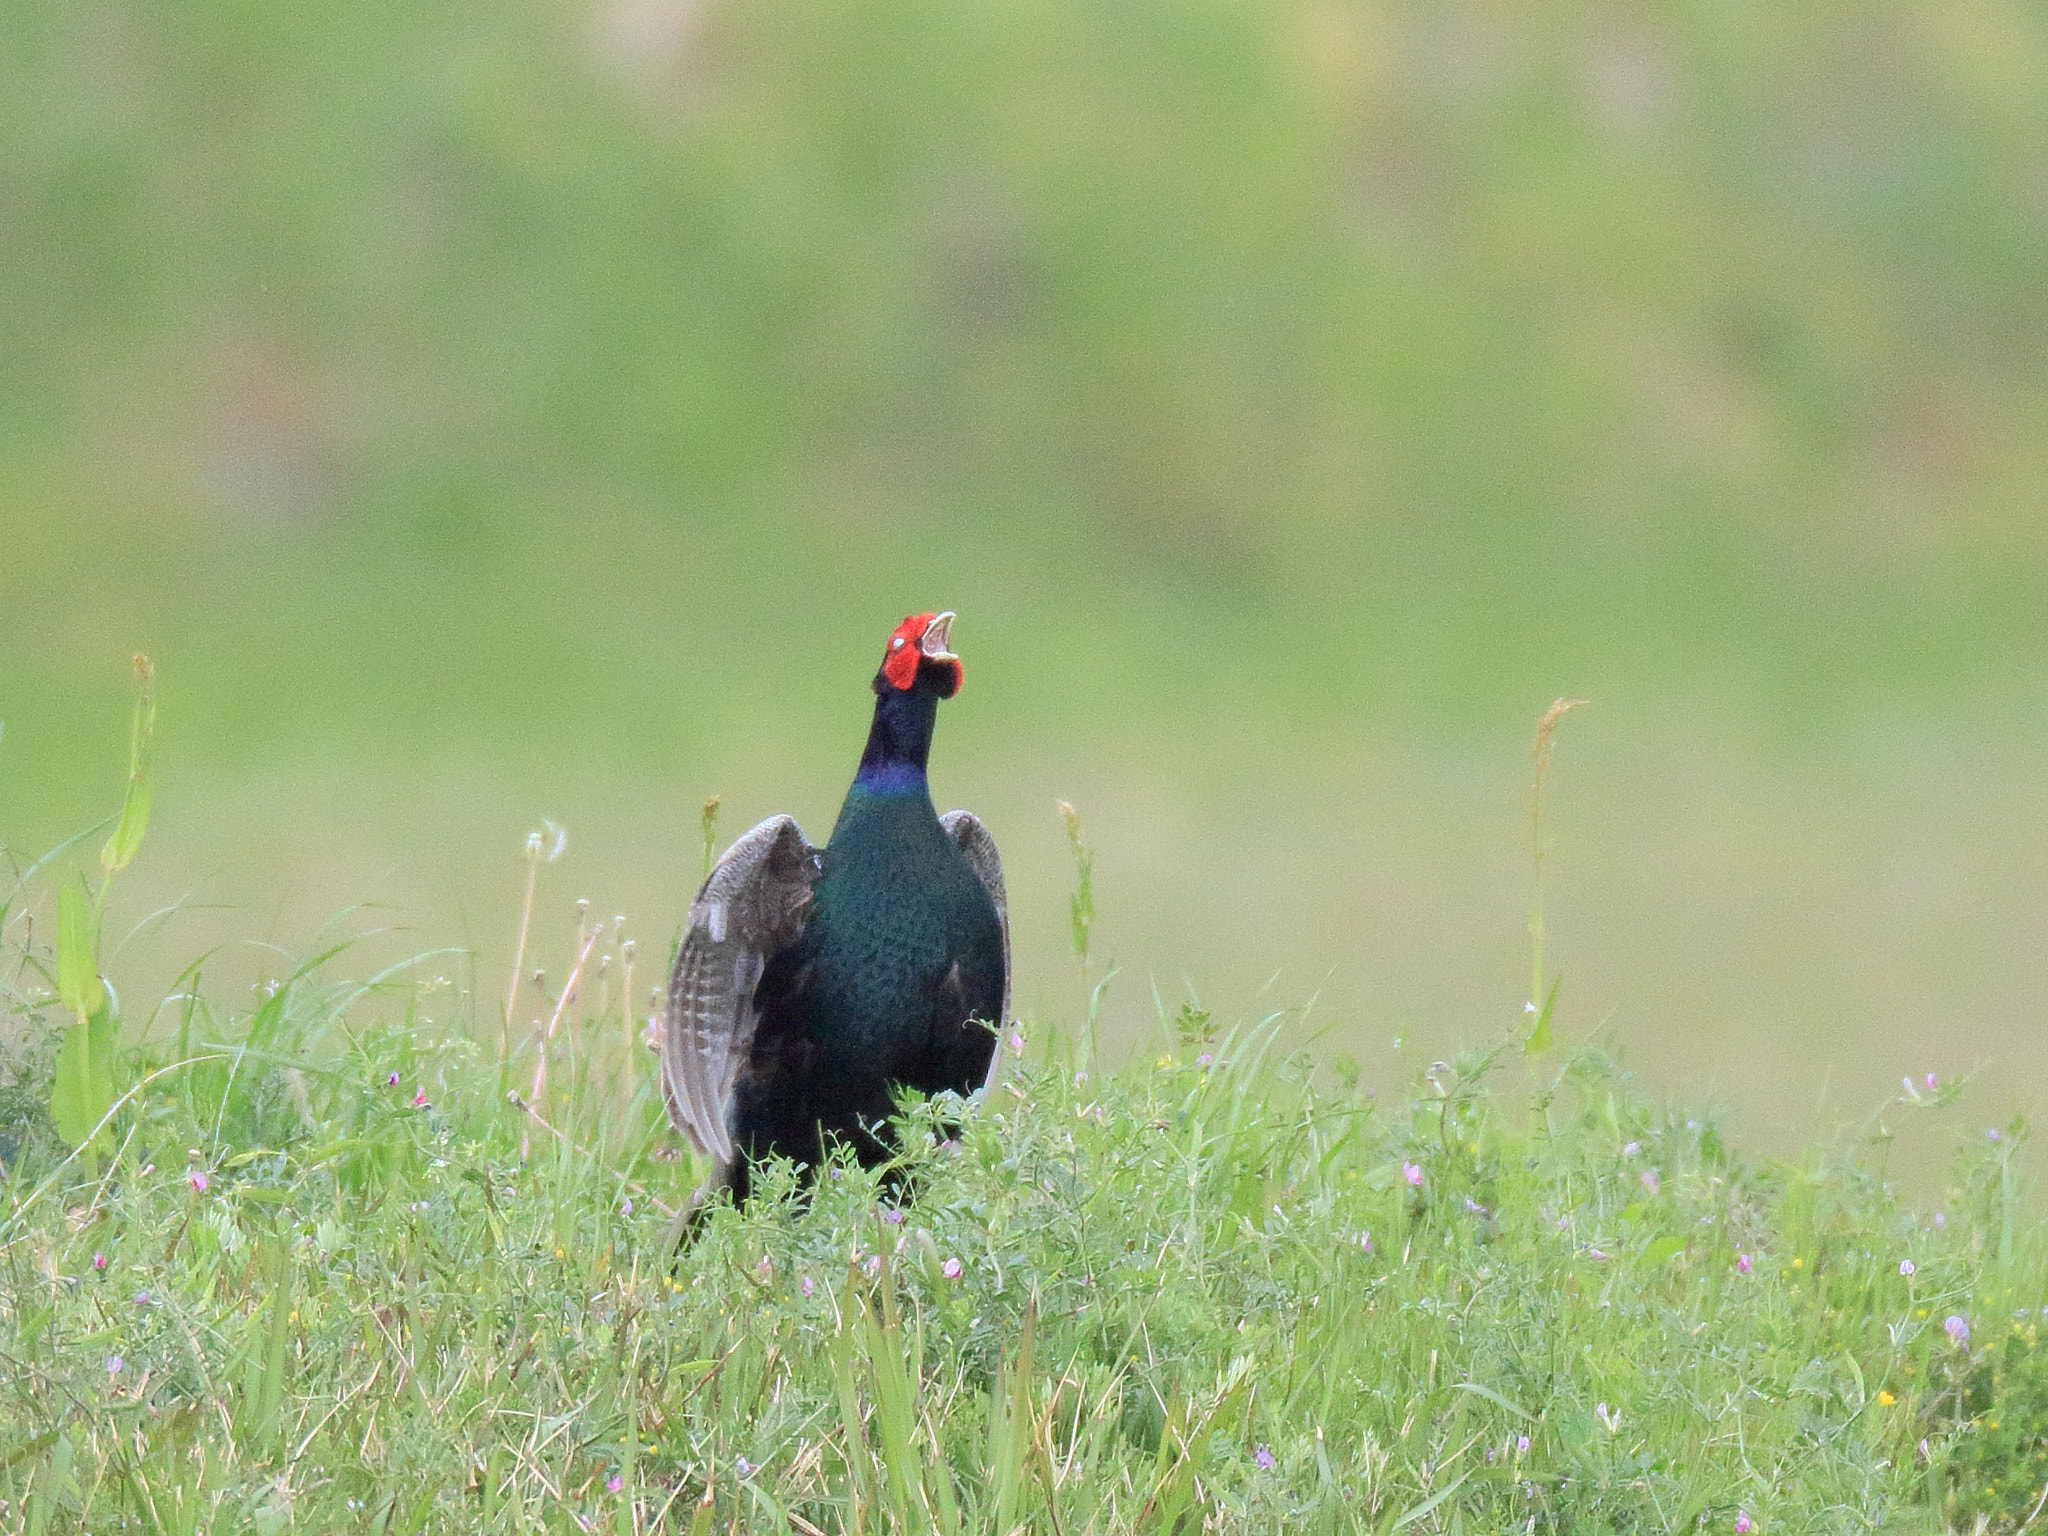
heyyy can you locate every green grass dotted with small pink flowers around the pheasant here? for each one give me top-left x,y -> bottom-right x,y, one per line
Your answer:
0,860 -> 2048,1536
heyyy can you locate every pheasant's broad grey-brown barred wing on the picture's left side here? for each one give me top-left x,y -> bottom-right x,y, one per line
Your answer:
662,815 -> 819,1167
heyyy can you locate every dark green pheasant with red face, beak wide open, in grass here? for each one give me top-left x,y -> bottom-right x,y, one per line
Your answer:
662,612 -> 1010,1212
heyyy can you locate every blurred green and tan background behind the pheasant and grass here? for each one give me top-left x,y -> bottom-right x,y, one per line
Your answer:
0,0 -> 2048,1145
